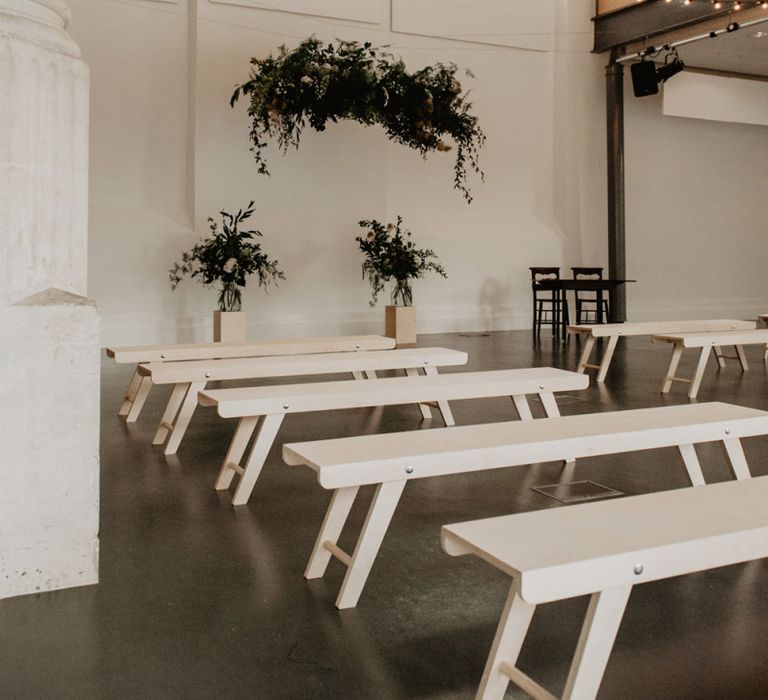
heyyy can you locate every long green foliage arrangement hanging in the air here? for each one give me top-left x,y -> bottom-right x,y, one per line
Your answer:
230,37 -> 485,202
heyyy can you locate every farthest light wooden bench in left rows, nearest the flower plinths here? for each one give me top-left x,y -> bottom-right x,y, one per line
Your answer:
107,335 -> 395,423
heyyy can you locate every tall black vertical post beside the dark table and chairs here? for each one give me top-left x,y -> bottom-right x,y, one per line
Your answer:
605,62 -> 627,322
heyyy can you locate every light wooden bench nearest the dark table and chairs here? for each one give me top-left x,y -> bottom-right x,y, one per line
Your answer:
568,319 -> 757,382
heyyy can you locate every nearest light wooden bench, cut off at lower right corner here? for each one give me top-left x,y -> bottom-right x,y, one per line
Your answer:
442,476 -> 768,700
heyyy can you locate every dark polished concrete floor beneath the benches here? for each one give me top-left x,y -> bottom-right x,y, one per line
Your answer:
0,331 -> 768,699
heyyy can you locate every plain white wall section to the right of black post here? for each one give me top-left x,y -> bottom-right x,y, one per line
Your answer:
625,72 -> 768,320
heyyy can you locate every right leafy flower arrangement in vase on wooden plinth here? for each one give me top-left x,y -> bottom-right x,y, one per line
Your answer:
355,216 -> 448,306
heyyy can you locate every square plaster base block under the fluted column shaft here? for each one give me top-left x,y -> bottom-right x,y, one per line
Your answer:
0,289 -> 100,598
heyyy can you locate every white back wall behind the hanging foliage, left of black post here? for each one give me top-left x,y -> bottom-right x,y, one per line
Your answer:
67,0 -> 604,344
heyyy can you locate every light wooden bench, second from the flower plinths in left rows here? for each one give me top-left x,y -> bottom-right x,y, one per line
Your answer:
138,348 -> 468,454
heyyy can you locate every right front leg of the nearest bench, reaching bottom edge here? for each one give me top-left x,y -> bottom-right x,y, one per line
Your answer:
563,586 -> 632,700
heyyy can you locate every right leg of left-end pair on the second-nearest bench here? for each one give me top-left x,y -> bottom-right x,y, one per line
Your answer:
336,481 -> 405,610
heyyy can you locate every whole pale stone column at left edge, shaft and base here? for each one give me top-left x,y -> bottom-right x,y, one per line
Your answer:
0,0 -> 99,598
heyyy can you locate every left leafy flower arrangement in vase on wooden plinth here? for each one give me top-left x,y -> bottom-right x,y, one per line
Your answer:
168,202 -> 285,311
